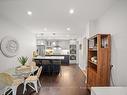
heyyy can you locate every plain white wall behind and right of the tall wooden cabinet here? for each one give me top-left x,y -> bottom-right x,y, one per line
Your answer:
90,0 -> 127,86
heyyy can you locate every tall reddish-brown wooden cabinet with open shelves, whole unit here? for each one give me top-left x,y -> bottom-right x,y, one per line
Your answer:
87,34 -> 111,87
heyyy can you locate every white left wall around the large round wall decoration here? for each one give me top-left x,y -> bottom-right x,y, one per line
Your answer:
0,17 -> 36,72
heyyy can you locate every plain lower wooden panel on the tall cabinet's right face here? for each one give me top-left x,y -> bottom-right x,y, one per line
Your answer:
98,48 -> 110,86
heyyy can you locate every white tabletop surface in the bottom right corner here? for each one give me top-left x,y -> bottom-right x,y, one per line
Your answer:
91,87 -> 127,95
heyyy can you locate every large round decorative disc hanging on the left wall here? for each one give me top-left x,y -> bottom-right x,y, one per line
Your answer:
1,36 -> 19,57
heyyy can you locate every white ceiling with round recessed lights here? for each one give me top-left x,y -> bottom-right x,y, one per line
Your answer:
0,0 -> 116,36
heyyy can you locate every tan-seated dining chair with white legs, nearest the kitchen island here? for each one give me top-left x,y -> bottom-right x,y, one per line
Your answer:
23,66 -> 42,94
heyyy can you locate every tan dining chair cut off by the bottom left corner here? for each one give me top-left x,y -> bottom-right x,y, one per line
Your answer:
0,73 -> 24,95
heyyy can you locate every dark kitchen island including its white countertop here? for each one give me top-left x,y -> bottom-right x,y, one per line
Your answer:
33,56 -> 64,75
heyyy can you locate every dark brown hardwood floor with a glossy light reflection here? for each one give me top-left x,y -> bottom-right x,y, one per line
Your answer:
17,65 -> 90,95
